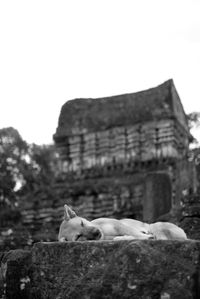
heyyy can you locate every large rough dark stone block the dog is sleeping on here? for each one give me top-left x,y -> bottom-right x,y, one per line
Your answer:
32,240 -> 200,299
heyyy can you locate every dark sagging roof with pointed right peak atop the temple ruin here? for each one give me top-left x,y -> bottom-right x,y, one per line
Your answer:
54,80 -> 188,141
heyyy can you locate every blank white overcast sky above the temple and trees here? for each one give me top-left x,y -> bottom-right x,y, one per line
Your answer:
0,0 -> 200,144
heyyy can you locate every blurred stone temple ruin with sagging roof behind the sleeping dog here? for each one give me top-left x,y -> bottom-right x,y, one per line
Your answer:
54,80 -> 196,222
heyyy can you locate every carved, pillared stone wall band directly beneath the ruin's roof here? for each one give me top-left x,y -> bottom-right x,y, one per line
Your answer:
57,119 -> 188,173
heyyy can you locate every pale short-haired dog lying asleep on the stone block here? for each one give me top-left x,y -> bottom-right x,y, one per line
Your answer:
58,205 -> 187,242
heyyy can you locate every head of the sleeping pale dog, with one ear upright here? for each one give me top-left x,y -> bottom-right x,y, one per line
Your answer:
58,205 -> 103,242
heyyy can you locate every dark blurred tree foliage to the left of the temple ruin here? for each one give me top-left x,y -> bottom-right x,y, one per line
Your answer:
0,127 -> 59,230
